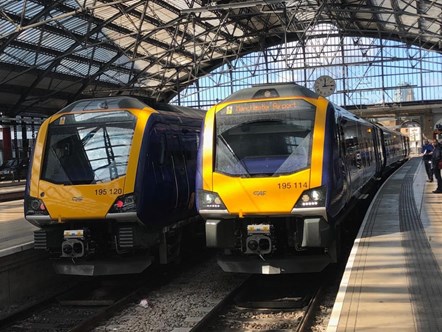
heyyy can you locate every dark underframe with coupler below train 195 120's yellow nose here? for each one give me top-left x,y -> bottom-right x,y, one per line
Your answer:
34,218 -> 195,276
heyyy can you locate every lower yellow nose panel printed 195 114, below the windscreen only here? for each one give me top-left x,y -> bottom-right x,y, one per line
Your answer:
213,169 -> 310,216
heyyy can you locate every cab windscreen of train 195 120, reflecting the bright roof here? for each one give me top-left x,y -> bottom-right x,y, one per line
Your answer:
42,111 -> 136,185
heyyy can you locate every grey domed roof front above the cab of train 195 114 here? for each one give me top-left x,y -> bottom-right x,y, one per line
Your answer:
223,83 -> 319,102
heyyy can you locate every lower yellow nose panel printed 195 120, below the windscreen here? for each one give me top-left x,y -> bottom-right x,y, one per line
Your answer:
38,178 -> 124,221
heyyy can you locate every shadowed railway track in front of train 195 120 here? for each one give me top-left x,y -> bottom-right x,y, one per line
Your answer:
0,276 -> 148,332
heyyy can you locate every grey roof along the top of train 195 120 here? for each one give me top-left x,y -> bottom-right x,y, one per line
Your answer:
57,96 -> 205,118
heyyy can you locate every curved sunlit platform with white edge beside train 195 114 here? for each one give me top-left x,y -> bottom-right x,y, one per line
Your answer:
327,157 -> 442,332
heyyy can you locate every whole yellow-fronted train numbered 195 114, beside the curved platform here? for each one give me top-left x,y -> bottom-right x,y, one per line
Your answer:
197,84 -> 403,274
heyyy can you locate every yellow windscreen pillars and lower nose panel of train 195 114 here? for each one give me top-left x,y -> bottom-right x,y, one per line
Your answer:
203,94 -> 328,216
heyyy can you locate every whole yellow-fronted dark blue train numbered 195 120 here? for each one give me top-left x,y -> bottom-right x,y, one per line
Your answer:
24,97 -> 204,275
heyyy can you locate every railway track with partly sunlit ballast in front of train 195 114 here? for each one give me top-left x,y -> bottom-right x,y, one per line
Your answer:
191,268 -> 336,332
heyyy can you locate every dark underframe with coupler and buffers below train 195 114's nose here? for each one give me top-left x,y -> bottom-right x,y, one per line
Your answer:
206,217 -> 339,274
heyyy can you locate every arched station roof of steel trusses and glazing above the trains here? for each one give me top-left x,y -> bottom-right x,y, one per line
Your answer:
0,0 -> 442,116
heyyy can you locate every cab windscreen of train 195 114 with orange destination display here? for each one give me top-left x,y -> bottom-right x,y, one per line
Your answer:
215,99 -> 316,177
